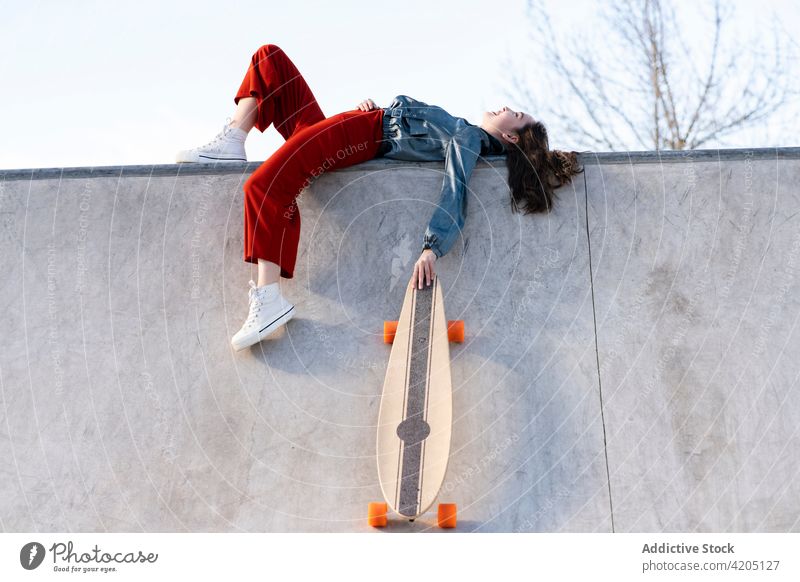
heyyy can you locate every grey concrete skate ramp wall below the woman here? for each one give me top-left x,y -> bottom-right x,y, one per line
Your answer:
0,149 -> 800,532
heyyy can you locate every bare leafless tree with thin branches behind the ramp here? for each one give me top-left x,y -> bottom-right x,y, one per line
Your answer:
508,0 -> 797,150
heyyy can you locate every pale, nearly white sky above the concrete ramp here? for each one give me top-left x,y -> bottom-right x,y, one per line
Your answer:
0,0 -> 800,169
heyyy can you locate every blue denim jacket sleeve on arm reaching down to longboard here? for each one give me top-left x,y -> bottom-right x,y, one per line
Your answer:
423,126 -> 482,257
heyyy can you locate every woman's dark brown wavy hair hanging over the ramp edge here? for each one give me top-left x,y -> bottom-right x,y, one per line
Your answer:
506,121 -> 583,214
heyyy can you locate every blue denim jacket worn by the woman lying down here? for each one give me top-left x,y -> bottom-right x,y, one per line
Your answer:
381,95 -> 505,257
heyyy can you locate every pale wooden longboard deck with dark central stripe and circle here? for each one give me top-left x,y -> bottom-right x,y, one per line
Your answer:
377,275 -> 453,519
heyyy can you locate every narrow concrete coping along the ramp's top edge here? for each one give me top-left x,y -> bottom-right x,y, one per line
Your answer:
0,147 -> 800,181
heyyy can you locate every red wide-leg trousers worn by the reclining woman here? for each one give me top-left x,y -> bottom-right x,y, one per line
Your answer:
234,44 -> 383,279
